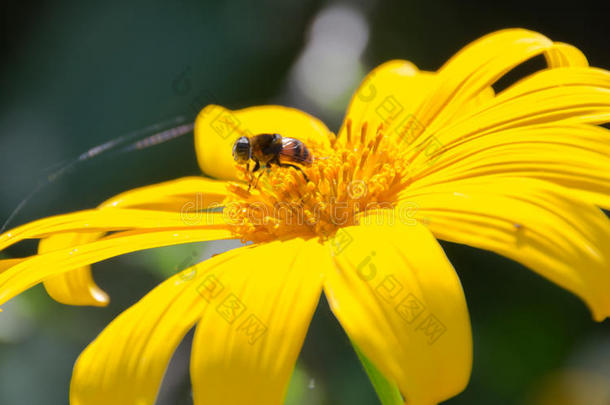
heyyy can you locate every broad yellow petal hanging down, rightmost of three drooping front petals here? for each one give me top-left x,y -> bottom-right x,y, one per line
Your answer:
324,216 -> 472,405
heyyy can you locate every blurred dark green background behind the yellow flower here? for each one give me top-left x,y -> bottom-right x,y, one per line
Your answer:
0,0 -> 610,405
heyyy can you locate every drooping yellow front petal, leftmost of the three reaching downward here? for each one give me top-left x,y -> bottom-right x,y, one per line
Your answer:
70,249 -> 243,405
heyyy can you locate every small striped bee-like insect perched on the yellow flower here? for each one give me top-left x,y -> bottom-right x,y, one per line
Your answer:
233,134 -> 313,190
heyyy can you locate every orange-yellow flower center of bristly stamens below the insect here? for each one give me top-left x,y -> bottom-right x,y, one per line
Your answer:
223,121 -> 408,242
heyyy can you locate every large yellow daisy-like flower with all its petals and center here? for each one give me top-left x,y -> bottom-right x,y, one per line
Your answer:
0,29 -> 610,405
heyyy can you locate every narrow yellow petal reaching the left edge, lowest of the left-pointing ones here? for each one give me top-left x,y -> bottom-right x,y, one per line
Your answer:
0,227 -> 232,305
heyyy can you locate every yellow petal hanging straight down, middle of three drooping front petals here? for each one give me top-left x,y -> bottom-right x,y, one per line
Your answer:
191,239 -> 332,405
